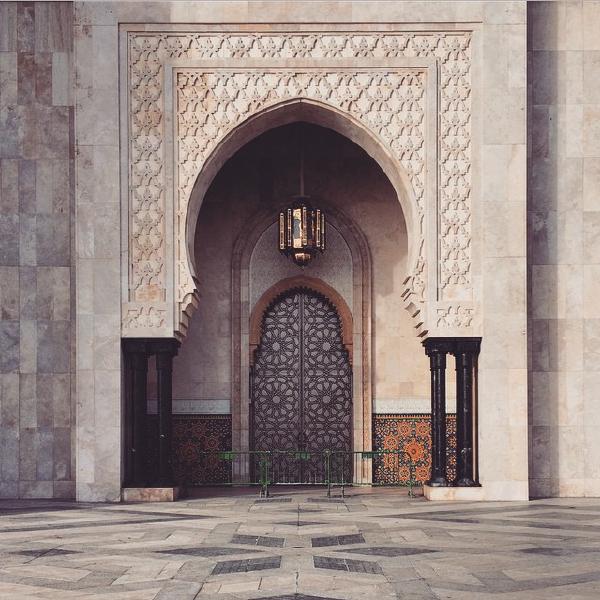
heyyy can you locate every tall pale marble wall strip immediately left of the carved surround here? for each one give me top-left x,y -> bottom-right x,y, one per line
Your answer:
71,2 -> 120,501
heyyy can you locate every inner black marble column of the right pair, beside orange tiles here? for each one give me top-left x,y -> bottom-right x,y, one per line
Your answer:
423,338 -> 452,486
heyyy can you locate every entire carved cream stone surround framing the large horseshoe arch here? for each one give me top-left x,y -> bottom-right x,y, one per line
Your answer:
122,30 -> 475,337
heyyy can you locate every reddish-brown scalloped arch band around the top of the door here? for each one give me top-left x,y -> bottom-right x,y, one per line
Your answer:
249,275 -> 353,365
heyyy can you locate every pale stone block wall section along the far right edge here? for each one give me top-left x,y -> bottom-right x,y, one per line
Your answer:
528,0 -> 600,496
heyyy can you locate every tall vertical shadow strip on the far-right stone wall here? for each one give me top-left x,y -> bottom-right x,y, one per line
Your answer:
527,2 -> 564,497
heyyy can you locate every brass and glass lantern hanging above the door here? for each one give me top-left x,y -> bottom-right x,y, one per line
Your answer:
279,195 -> 325,267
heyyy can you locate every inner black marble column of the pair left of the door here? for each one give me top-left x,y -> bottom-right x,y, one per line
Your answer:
152,339 -> 179,487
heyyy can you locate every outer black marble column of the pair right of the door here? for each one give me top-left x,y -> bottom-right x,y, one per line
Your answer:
454,338 -> 481,487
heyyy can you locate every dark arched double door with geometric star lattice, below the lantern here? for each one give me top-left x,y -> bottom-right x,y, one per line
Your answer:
252,289 -> 352,483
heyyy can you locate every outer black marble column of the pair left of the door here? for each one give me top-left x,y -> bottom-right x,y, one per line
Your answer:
123,339 -> 148,486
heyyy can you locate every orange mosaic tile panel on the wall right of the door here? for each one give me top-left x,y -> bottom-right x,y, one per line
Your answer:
373,414 -> 456,484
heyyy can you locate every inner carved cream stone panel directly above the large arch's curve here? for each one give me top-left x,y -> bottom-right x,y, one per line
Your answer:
176,69 -> 425,314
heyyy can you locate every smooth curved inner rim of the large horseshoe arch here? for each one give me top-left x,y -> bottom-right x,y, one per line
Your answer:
177,98 -> 426,331
